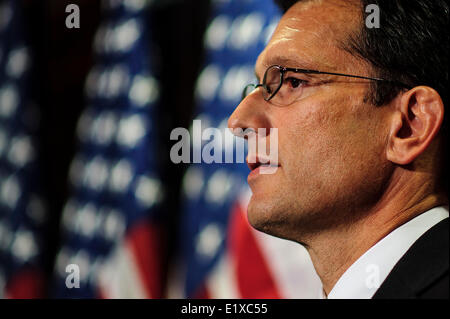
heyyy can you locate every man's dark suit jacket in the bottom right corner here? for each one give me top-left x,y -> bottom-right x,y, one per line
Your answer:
373,218 -> 449,299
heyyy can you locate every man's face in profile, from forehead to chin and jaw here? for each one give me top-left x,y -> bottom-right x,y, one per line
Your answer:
229,0 -> 392,241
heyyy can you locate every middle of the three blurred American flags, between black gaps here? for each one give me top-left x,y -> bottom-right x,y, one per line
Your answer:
53,0 -> 164,298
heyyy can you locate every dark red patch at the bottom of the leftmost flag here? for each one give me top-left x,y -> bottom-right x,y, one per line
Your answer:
6,269 -> 45,299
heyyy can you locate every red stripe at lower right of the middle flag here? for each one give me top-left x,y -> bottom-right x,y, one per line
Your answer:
126,222 -> 165,298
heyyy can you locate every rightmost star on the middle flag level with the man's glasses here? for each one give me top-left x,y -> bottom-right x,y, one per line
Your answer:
129,75 -> 159,107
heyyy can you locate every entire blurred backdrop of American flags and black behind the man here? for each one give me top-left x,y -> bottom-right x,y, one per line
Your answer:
0,0 -> 321,298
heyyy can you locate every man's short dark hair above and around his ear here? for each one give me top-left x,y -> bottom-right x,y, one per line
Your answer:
276,0 -> 449,194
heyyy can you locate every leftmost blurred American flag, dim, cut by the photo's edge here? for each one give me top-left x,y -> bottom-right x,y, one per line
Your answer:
0,0 -> 47,298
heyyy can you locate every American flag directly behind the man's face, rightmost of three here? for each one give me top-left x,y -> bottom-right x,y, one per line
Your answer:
169,0 -> 321,298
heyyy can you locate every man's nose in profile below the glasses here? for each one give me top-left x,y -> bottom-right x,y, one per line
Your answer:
228,90 -> 270,138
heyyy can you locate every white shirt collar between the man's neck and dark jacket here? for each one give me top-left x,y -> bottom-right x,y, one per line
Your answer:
322,206 -> 449,299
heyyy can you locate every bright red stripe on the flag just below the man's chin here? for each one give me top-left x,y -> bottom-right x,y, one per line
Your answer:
228,205 -> 281,299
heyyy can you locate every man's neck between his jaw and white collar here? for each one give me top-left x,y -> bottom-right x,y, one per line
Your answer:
306,171 -> 448,294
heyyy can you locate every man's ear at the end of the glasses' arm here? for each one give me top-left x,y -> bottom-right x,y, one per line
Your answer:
386,86 -> 444,165
